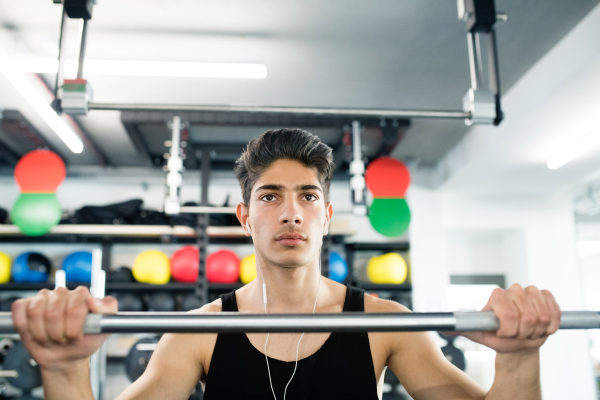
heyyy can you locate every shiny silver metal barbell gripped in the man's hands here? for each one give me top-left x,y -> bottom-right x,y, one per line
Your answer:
0,311 -> 600,334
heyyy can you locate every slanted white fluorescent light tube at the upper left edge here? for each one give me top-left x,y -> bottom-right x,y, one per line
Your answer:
0,54 -> 83,153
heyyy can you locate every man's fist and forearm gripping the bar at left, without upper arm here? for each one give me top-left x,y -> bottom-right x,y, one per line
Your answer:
12,286 -> 117,400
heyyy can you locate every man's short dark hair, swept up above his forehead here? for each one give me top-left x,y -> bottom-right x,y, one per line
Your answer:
234,128 -> 334,207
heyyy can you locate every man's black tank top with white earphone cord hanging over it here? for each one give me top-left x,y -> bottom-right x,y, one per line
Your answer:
204,286 -> 378,400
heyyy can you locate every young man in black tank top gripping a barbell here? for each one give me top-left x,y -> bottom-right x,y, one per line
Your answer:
13,129 -> 560,400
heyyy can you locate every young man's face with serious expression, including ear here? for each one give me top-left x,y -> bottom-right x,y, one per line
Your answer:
238,160 -> 333,268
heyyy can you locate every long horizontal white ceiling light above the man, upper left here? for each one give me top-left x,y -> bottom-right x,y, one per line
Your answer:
12,57 -> 267,79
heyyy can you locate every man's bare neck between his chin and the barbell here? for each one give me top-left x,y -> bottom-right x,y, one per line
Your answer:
252,255 -> 323,313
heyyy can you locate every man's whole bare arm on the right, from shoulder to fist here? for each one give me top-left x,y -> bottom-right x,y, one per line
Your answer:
372,285 -> 561,400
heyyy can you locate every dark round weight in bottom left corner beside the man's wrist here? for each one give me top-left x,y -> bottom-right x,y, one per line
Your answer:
2,342 -> 42,392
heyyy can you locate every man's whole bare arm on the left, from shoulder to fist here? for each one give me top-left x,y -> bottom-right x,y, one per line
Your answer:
12,286 -> 221,400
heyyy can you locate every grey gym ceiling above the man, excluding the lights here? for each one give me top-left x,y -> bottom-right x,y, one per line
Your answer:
0,0 -> 598,175
